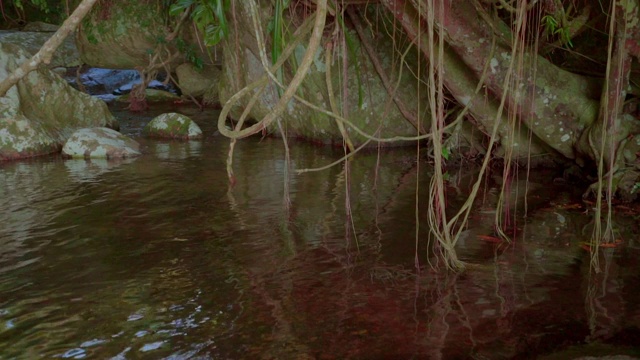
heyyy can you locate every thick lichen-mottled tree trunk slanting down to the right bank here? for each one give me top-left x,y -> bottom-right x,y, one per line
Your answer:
382,0 -> 640,197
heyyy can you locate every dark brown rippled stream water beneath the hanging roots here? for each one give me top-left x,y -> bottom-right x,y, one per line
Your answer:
0,103 -> 640,359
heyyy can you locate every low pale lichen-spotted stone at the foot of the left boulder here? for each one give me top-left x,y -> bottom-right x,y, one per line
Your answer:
62,128 -> 141,159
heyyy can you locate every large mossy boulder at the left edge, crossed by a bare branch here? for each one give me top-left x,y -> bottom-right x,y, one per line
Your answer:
0,40 -> 118,160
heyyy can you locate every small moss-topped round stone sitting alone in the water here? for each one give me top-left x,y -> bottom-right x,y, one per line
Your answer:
143,113 -> 202,139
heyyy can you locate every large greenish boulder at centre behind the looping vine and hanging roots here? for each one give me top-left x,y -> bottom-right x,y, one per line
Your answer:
219,2 -> 429,146
